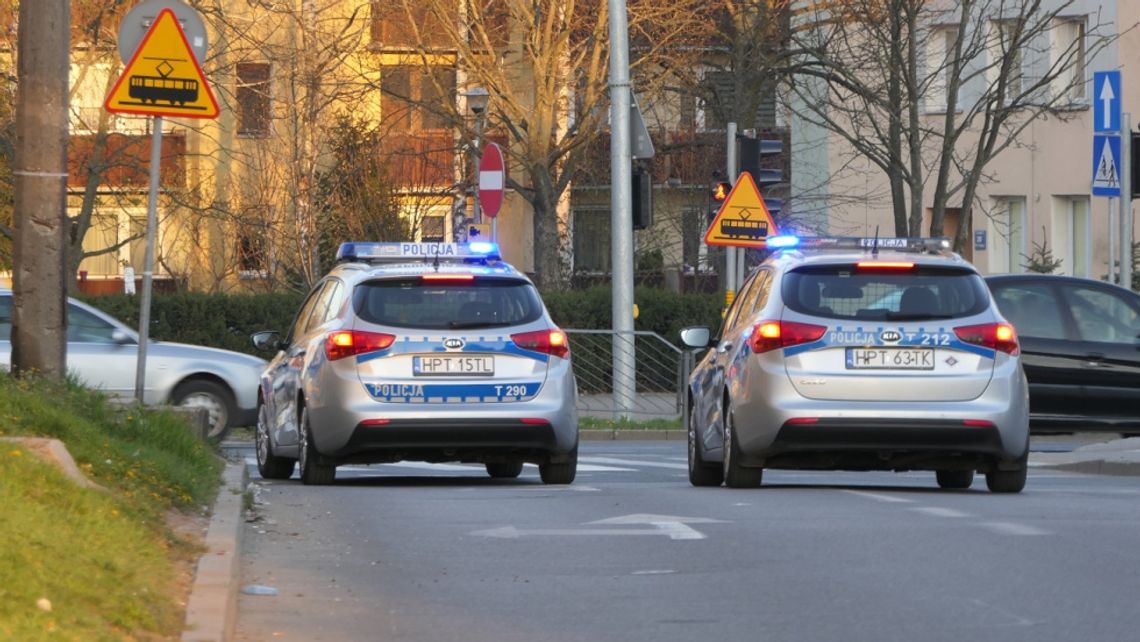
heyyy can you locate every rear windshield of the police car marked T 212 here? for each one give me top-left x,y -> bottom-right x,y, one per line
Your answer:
782,265 -> 990,320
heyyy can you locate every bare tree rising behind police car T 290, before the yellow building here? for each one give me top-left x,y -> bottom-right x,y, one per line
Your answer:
373,0 -> 702,289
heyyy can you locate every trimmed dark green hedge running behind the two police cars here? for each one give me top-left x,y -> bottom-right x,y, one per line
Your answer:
83,286 -> 720,356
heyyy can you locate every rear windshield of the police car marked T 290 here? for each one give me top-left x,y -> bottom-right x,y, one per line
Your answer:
352,277 -> 543,330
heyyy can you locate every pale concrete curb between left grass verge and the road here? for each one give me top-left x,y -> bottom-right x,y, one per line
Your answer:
181,461 -> 249,642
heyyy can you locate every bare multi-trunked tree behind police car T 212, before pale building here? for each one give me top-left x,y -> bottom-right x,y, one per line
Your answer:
785,0 -> 1123,249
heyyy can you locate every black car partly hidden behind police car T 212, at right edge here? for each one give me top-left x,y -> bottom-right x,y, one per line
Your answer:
986,274 -> 1140,432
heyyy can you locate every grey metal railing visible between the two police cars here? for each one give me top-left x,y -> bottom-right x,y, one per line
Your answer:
564,328 -> 693,421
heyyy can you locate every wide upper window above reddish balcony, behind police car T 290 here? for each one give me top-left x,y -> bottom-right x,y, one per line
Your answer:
380,65 -> 456,132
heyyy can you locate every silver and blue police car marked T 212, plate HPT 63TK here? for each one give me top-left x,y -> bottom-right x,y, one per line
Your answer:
682,236 -> 1029,493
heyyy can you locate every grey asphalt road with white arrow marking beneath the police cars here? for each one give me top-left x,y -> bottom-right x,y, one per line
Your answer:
235,438 -> 1140,642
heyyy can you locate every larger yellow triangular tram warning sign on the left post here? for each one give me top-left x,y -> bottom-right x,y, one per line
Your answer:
104,8 -> 218,119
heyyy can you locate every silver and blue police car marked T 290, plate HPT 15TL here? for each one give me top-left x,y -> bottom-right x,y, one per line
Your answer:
253,242 -> 578,485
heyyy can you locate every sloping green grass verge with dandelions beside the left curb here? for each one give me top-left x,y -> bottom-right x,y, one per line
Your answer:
0,373 -> 223,641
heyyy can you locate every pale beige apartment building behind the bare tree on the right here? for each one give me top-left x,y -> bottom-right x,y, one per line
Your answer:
789,0 -> 1140,278
